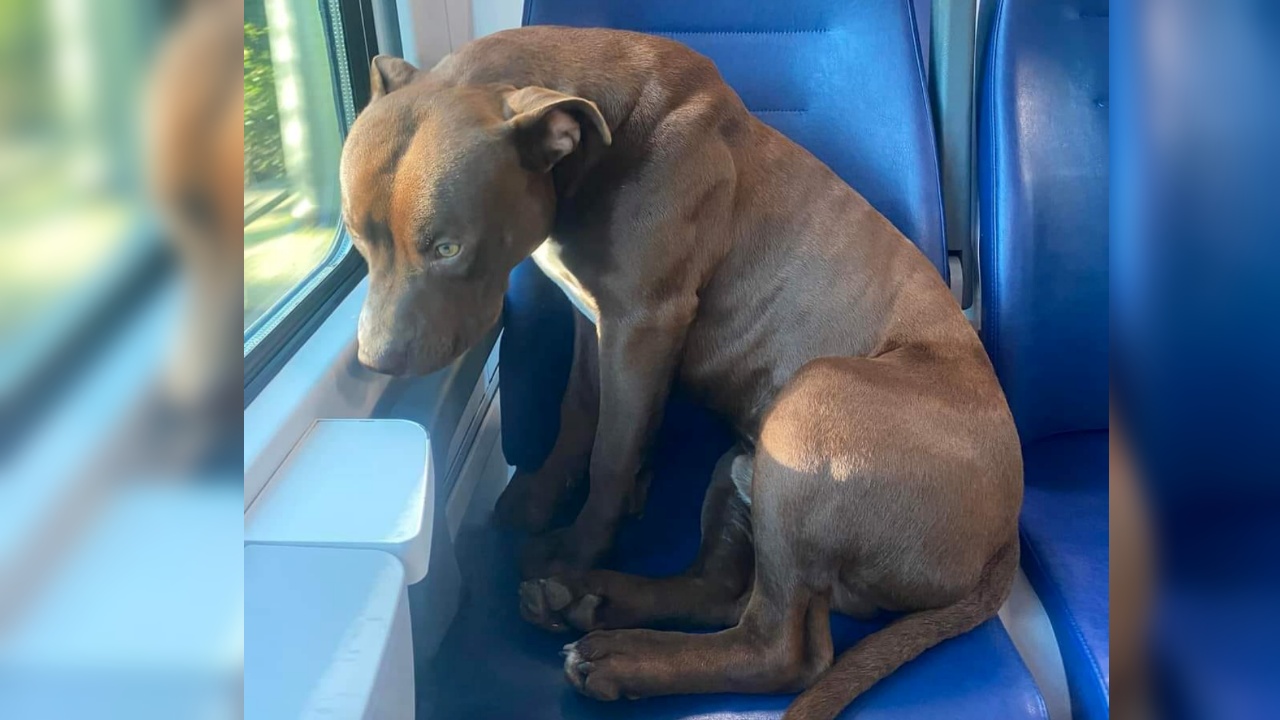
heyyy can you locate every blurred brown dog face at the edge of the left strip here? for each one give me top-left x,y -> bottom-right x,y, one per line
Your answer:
146,0 -> 244,415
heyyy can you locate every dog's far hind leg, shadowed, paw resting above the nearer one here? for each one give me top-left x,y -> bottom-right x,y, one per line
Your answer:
520,448 -> 754,630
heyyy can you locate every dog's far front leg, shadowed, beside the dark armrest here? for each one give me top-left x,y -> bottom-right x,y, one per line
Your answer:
494,313 -> 600,533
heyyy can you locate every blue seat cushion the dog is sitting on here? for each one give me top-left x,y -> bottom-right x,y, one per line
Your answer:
419,393 -> 1046,720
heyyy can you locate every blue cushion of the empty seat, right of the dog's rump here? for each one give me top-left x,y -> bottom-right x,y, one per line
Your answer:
1021,430 -> 1110,719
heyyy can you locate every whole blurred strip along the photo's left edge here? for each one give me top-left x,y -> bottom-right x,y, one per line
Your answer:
0,0 -> 241,719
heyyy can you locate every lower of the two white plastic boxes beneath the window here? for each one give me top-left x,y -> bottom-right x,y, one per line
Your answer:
244,546 -> 413,720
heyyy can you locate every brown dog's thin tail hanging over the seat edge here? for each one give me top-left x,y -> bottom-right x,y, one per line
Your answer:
782,537 -> 1019,720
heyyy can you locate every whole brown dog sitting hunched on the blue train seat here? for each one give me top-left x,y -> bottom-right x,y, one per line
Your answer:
342,27 -> 1023,717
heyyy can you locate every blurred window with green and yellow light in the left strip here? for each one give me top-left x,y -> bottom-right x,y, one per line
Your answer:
0,0 -> 162,397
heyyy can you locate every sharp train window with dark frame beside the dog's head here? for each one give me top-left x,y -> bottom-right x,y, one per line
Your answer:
244,0 -> 376,396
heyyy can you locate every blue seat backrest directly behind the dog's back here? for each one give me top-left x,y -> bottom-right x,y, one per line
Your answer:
525,0 -> 947,277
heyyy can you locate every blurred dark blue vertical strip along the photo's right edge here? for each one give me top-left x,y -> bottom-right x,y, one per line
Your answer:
1111,0 -> 1280,717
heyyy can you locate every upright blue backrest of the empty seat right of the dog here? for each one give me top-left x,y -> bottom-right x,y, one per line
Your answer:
978,0 -> 1108,442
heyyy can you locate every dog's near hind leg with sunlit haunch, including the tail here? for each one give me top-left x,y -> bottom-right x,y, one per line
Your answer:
564,350 -> 1021,702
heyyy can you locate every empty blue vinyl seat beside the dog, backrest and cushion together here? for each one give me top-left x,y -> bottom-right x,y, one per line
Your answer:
978,0 -> 1110,719
